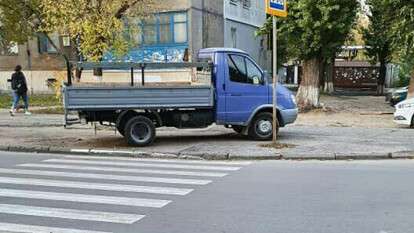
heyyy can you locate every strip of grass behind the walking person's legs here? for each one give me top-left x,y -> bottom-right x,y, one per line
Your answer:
0,94 -> 62,108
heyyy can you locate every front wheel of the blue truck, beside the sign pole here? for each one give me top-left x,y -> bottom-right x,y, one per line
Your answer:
249,112 -> 279,141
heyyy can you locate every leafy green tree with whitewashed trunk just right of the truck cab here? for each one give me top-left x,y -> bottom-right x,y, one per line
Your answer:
267,0 -> 359,110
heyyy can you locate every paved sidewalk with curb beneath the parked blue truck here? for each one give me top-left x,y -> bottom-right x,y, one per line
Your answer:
0,110 -> 414,160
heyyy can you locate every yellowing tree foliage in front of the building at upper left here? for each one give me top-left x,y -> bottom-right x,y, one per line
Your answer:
0,0 -> 156,67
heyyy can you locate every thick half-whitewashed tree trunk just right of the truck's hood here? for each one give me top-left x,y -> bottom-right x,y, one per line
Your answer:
297,58 -> 320,111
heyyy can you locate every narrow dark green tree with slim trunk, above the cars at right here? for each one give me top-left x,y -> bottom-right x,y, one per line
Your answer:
362,0 -> 397,95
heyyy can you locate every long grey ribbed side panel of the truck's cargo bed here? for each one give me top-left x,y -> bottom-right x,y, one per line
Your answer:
64,85 -> 214,111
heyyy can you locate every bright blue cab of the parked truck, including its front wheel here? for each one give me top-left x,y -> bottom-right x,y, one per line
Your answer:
198,48 -> 298,139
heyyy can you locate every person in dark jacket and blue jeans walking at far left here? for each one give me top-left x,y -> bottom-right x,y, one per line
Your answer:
10,65 -> 31,116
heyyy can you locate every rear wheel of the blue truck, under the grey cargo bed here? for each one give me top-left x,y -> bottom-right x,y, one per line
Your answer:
125,116 -> 156,147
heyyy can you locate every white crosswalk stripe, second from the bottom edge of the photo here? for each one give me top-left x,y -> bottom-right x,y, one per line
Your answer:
0,204 -> 145,224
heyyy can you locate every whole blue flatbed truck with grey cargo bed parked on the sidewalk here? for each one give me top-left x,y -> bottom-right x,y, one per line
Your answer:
63,48 -> 298,147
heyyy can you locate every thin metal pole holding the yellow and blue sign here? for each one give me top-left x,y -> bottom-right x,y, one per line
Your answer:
272,16 -> 278,143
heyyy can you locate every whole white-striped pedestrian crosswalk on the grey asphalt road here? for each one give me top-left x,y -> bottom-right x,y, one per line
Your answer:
0,156 -> 250,233
